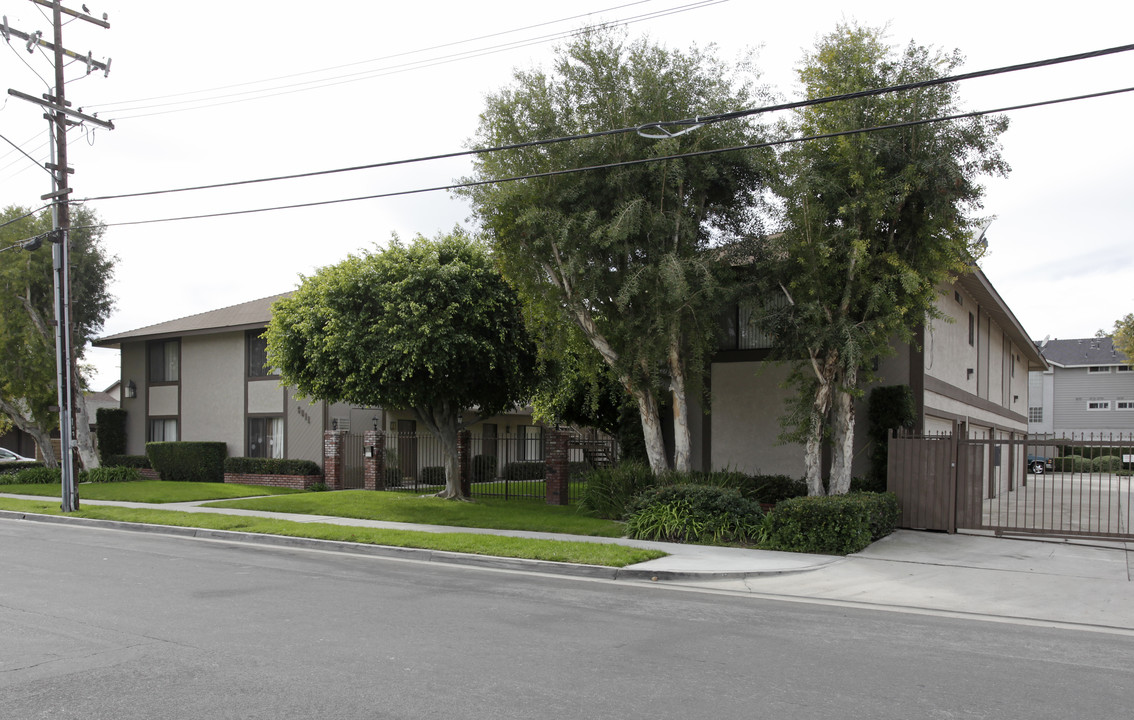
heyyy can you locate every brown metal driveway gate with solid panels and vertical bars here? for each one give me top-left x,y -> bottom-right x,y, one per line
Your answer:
888,425 -> 1134,540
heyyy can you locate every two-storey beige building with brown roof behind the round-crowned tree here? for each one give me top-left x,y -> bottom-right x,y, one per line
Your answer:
94,294 -> 542,466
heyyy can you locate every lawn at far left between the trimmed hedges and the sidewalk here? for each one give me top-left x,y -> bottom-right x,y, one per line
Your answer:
0,480 -> 304,502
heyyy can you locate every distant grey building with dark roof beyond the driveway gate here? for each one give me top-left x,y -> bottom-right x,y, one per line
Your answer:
1027,337 -> 1134,437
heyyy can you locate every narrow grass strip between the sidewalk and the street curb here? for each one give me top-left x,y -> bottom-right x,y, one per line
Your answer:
0,493 -> 666,568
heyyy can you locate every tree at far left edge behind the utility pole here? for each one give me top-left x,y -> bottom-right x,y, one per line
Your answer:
0,205 -> 116,469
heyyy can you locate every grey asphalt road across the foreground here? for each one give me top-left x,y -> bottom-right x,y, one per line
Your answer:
0,520 -> 1134,720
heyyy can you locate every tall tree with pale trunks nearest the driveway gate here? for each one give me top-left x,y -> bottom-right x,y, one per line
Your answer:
747,24 -> 1008,494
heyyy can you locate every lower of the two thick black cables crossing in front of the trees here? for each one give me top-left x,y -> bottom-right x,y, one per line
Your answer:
68,86 -> 1134,232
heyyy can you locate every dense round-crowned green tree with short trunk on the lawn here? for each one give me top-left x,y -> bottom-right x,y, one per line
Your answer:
266,228 -> 534,499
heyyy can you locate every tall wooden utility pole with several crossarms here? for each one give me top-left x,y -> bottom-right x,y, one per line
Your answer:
0,0 -> 115,513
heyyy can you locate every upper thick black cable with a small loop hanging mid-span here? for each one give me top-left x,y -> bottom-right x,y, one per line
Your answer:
78,44 -> 1134,202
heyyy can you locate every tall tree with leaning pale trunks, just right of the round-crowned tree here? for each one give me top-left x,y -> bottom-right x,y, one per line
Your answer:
466,31 -> 770,472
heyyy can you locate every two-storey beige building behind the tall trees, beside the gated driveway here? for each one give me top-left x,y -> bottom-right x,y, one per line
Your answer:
693,268 -> 1047,477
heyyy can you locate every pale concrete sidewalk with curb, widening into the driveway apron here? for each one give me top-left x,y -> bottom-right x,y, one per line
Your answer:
0,494 -> 1134,634
